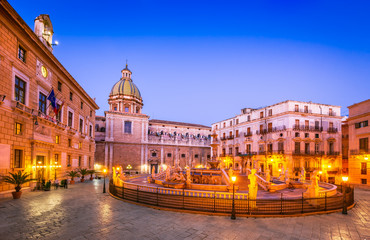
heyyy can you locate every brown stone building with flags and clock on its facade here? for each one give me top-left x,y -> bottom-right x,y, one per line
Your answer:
0,1 -> 98,194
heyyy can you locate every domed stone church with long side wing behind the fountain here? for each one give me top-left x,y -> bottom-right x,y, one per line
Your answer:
96,65 -> 211,173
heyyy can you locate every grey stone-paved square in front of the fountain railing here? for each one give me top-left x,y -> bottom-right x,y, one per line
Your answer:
0,180 -> 370,240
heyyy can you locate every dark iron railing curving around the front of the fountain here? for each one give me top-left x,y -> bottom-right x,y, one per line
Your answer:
109,182 -> 354,216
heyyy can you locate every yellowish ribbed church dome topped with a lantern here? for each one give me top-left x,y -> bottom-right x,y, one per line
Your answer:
109,64 -> 141,100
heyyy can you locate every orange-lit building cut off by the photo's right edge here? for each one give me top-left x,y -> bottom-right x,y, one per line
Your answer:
347,99 -> 370,186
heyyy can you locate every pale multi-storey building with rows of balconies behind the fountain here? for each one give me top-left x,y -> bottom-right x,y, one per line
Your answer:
212,100 -> 342,182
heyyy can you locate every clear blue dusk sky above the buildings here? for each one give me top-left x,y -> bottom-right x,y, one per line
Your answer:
9,0 -> 370,125
